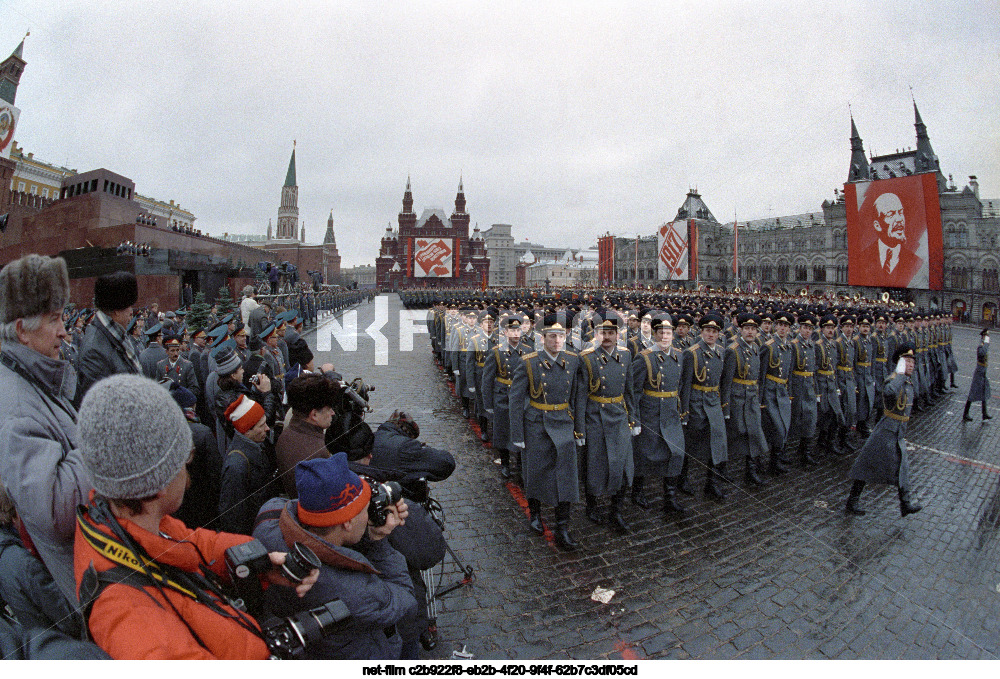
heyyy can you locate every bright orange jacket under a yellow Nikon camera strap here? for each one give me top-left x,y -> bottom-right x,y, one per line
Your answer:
73,516 -> 268,660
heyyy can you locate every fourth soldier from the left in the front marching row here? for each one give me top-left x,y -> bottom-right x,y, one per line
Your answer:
681,312 -> 729,500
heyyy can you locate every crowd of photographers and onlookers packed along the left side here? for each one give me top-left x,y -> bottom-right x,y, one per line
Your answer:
0,255 -> 455,659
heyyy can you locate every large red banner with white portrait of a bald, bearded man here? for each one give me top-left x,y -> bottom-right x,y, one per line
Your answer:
844,173 -> 944,290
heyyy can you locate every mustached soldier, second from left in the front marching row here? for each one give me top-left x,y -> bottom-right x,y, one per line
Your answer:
576,313 -> 639,533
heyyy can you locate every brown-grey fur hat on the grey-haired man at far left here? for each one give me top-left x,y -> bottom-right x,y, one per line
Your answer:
0,255 -> 69,323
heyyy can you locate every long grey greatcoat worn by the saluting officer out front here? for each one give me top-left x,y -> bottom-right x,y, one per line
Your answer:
850,372 -> 916,490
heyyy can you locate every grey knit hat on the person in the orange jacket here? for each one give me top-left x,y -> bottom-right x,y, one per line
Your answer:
79,375 -> 193,500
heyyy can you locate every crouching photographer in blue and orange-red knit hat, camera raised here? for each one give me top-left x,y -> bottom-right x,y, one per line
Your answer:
254,453 -> 416,660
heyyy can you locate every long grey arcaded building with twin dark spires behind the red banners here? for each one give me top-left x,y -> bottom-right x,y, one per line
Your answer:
602,104 -> 1000,325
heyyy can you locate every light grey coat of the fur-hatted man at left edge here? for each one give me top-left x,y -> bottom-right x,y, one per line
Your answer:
0,342 -> 93,603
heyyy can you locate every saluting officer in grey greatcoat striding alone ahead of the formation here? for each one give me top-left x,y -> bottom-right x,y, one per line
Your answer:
845,342 -> 923,516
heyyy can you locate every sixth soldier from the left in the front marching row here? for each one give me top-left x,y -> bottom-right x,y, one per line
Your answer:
759,311 -> 792,474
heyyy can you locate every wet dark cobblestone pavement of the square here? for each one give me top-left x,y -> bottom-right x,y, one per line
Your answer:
307,295 -> 1000,660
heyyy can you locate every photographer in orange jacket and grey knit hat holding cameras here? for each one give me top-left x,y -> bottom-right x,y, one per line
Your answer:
74,375 -> 319,659
